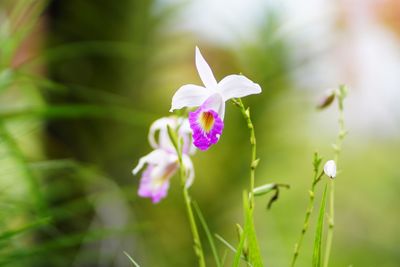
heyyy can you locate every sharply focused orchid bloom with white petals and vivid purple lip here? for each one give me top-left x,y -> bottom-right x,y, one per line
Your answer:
170,47 -> 261,150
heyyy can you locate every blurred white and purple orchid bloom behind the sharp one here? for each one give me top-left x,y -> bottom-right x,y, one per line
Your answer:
132,117 -> 195,203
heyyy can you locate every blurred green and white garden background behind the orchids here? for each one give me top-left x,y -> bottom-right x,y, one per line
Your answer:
0,0 -> 400,267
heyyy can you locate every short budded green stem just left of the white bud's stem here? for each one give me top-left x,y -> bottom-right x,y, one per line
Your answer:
290,168 -> 324,267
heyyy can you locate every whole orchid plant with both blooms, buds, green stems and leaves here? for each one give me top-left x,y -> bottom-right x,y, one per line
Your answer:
133,47 -> 347,267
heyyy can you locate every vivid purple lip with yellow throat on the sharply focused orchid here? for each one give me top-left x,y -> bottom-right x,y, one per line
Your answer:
189,107 -> 224,151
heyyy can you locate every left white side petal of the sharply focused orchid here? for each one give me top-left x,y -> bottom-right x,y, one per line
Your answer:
169,84 -> 210,112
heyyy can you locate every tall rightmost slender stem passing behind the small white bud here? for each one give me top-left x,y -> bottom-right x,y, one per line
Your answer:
324,87 -> 346,267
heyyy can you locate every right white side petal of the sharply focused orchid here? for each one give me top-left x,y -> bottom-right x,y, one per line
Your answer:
218,75 -> 261,101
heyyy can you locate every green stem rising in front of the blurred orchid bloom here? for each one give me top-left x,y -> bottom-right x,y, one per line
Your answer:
177,137 -> 206,267
